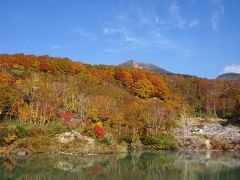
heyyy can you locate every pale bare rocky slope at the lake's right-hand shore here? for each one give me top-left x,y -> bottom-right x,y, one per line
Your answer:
173,119 -> 240,151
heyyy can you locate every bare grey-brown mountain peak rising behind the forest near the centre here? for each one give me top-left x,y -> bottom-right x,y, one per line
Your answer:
120,60 -> 173,75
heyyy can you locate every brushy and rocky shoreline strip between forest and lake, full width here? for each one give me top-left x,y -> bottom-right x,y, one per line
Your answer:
0,119 -> 240,156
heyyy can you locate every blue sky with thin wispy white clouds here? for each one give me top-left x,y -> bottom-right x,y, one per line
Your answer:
0,0 -> 240,78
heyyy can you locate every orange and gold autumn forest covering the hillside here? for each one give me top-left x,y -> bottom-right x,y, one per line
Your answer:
0,54 -> 240,139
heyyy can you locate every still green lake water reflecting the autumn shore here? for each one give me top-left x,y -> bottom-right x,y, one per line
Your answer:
0,152 -> 240,180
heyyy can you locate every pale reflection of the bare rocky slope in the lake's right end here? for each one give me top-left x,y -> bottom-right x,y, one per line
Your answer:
175,151 -> 240,180
